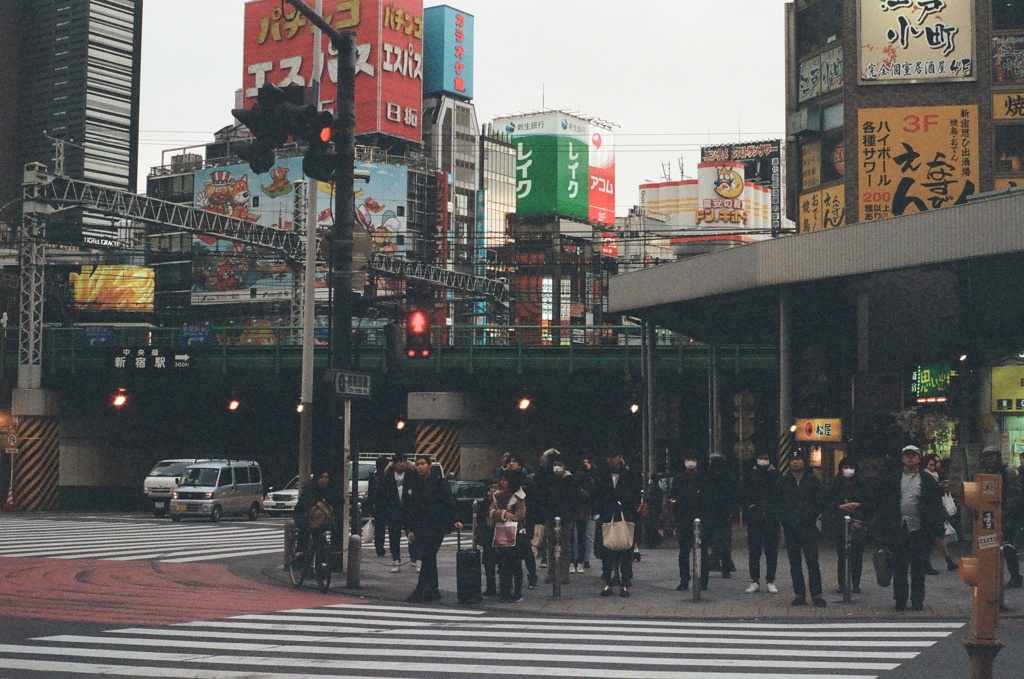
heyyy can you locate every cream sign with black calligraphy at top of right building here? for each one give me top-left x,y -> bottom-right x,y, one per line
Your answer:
857,0 -> 976,83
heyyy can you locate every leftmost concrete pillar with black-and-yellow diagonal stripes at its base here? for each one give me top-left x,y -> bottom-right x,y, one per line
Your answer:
10,389 -> 60,511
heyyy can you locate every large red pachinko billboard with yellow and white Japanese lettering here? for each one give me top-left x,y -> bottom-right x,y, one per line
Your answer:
243,0 -> 423,142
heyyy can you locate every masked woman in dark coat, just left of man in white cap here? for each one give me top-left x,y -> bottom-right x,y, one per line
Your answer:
827,458 -> 870,594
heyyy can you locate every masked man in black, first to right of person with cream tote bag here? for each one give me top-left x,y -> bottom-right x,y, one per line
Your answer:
672,452 -> 711,592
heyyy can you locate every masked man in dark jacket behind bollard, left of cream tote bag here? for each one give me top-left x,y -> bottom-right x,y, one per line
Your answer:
536,449 -> 580,585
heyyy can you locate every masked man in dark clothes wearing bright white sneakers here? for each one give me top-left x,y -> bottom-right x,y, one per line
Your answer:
743,453 -> 779,594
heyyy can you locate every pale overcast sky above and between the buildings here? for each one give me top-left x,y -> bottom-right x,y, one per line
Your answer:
138,0 -> 786,216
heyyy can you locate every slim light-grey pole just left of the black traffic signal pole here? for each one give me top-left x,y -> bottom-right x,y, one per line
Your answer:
299,0 -> 324,485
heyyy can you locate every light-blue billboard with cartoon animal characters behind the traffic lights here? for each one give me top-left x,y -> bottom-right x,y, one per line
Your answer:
191,157 -> 408,305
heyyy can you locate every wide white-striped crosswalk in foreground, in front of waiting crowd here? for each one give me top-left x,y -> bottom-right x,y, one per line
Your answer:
0,604 -> 962,679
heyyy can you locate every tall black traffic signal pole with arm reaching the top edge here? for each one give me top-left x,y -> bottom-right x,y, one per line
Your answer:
288,0 -> 359,588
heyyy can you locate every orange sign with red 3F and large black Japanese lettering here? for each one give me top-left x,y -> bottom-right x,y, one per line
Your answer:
857,105 -> 980,221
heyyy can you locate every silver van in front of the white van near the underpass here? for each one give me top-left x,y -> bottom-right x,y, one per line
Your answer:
170,460 -> 263,521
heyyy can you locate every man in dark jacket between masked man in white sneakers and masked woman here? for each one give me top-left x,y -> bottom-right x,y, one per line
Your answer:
775,449 -> 825,608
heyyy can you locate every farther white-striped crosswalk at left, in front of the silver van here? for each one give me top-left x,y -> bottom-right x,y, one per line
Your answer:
0,516 -> 456,563
